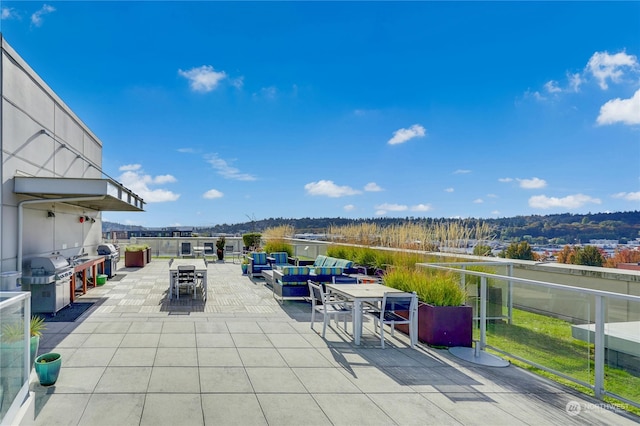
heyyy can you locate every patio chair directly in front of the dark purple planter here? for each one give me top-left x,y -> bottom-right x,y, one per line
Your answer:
364,292 -> 418,349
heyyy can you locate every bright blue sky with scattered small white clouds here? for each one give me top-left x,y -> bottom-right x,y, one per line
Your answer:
0,1 -> 640,227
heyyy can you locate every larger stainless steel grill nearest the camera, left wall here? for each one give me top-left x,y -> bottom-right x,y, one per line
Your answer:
22,254 -> 73,314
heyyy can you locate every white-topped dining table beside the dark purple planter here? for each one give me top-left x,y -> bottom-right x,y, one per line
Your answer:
326,284 -> 418,345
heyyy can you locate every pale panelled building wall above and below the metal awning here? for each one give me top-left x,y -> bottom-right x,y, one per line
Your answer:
0,35 -> 102,271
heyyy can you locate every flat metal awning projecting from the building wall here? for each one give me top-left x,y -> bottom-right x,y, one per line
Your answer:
13,176 -> 144,212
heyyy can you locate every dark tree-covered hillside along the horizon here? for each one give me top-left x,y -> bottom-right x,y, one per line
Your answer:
102,211 -> 640,244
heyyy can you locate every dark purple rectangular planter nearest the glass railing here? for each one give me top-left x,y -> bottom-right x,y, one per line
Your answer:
396,303 -> 473,348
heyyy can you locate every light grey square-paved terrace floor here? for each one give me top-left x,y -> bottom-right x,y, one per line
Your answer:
25,259 -> 638,426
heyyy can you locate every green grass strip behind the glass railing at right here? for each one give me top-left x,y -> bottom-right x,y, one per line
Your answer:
474,309 -> 640,415
